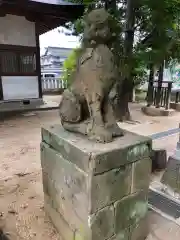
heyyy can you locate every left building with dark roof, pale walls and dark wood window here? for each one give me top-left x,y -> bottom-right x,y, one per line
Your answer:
0,0 -> 84,111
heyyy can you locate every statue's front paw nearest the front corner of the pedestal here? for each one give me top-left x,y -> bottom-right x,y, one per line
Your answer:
88,126 -> 113,143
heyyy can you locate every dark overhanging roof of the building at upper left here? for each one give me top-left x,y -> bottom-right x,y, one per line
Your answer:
0,0 -> 84,35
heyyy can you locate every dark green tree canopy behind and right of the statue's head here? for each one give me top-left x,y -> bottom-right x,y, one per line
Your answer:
65,0 -> 180,120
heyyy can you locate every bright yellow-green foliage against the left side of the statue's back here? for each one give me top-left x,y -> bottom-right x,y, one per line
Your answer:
62,48 -> 80,85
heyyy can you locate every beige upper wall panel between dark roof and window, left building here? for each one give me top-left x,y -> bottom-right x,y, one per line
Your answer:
0,15 -> 36,47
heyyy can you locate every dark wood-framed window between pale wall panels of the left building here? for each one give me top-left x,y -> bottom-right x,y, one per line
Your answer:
0,50 -> 36,76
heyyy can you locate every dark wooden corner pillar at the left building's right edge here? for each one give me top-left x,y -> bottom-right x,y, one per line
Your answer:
35,22 -> 42,98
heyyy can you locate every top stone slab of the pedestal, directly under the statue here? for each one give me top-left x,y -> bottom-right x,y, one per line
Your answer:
42,125 -> 152,174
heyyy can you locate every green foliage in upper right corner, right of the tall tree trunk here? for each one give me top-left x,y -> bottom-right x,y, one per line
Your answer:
138,0 -> 180,65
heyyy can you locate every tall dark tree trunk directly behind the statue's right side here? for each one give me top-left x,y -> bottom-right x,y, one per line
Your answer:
117,0 -> 135,121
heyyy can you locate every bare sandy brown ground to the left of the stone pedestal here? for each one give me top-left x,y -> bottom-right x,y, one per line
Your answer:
0,111 -> 60,240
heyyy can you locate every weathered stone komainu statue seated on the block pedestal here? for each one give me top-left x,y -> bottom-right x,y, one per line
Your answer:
59,9 -> 123,143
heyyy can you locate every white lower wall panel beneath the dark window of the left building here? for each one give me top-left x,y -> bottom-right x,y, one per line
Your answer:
2,76 -> 39,100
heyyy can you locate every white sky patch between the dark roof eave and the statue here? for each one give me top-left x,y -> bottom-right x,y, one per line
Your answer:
40,27 -> 80,54
